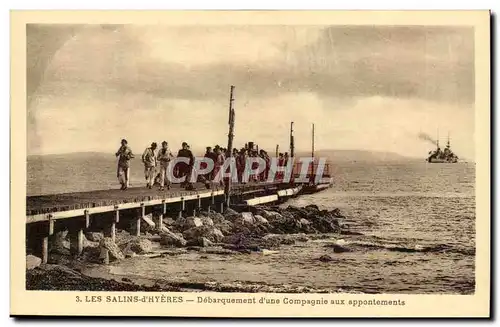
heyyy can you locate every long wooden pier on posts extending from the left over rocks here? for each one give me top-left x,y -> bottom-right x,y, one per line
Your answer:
26,178 -> 326,263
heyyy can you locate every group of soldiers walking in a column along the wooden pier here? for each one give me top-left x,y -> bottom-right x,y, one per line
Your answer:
116,139 -> 289,190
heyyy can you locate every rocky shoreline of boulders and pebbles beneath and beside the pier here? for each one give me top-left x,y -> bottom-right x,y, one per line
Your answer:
26,205 -> 353,293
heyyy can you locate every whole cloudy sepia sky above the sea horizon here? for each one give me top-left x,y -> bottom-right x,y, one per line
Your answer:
27,24 -> 475,159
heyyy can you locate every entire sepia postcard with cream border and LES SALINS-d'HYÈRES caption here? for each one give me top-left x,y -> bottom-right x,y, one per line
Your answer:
10,11 -> 491,318
